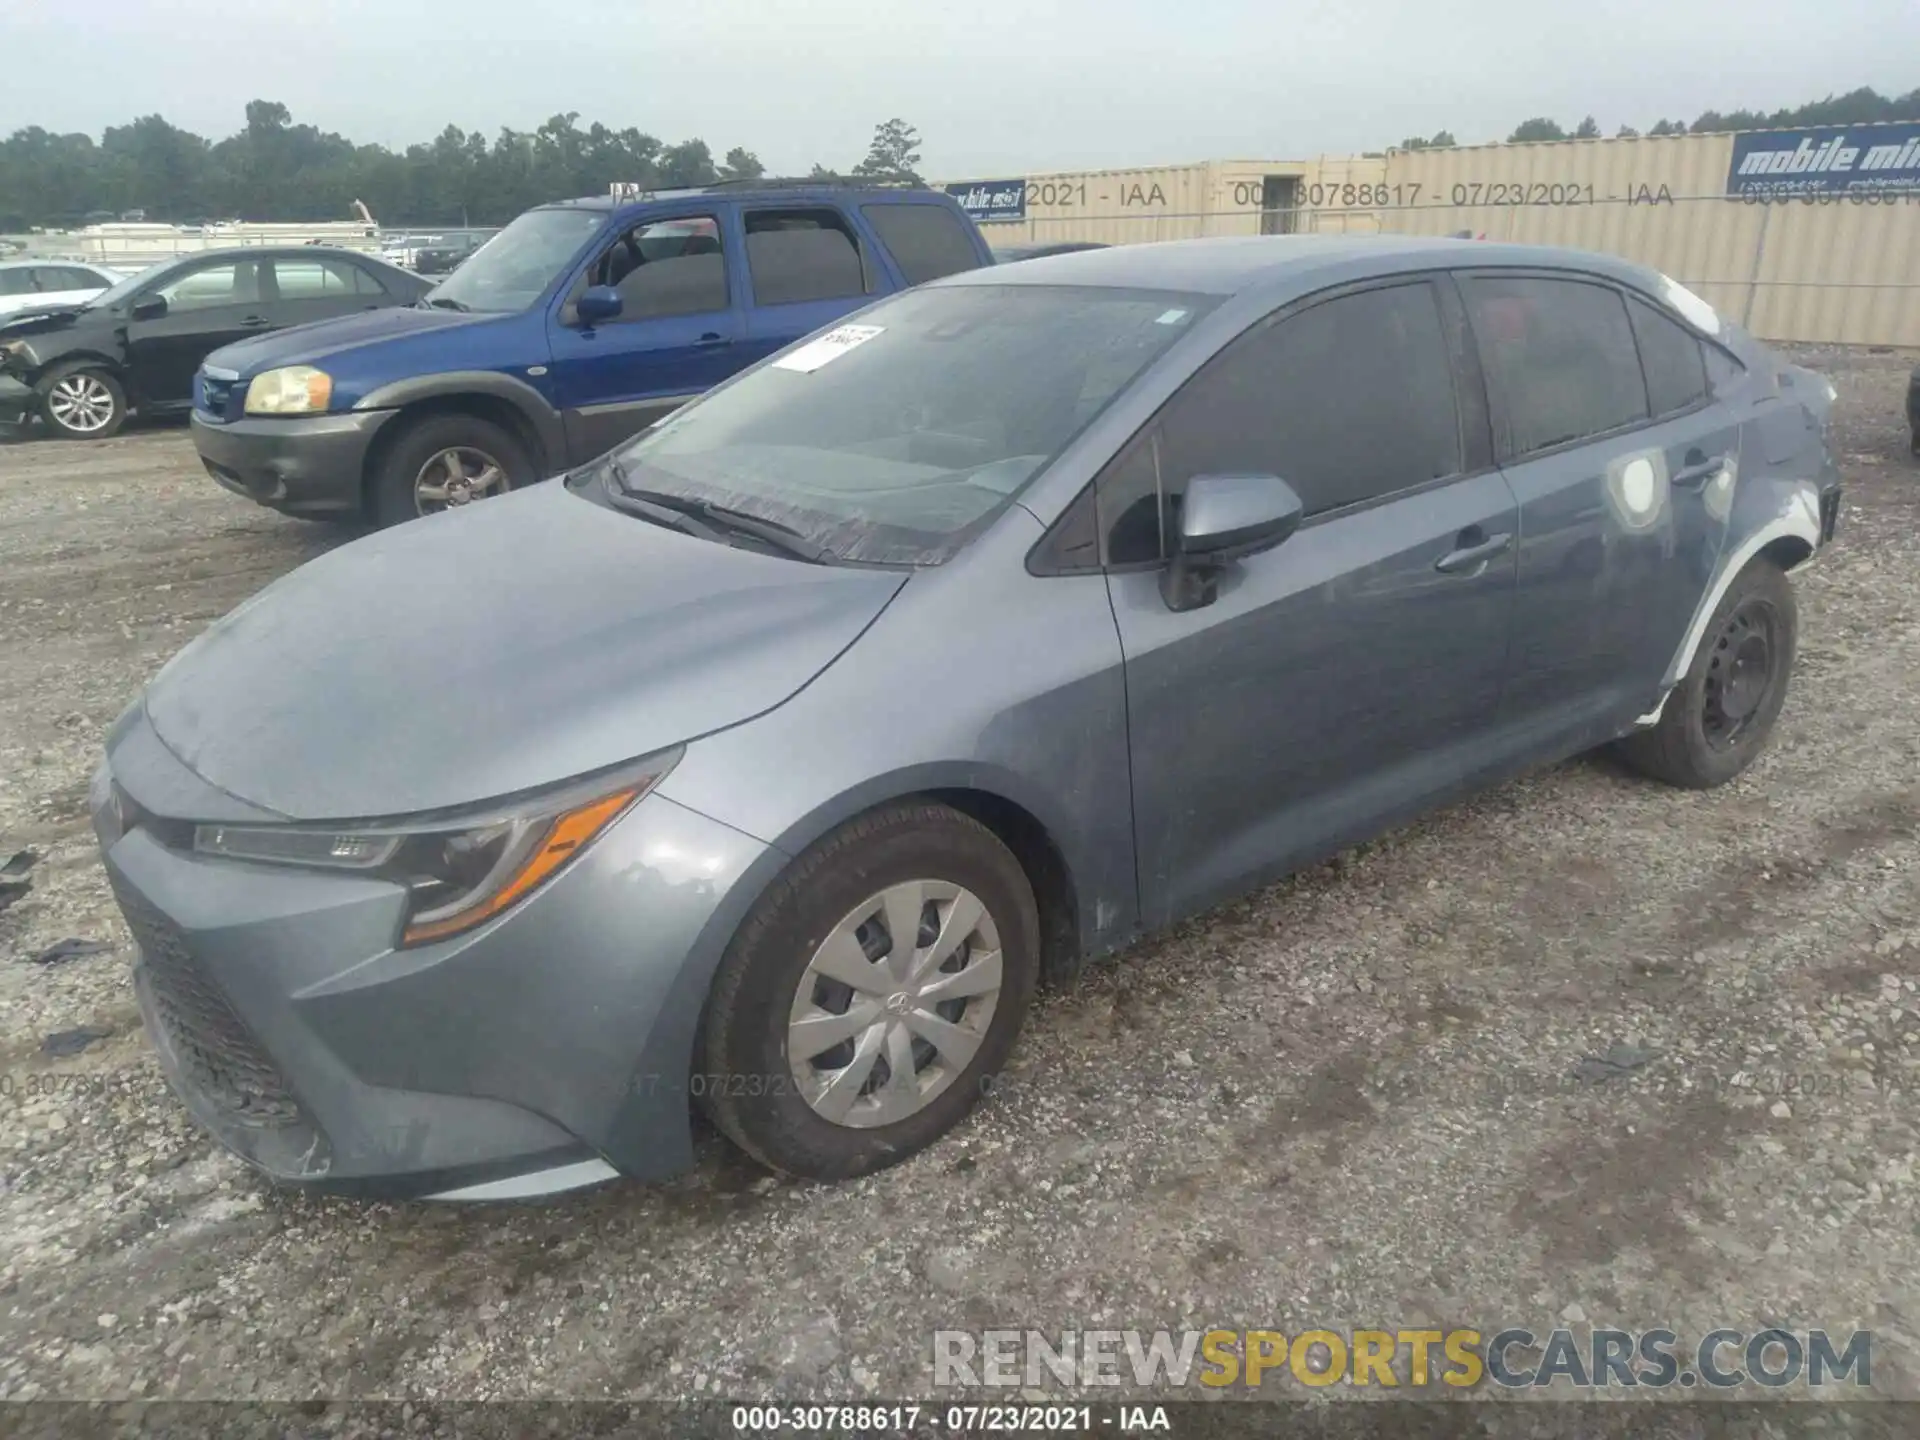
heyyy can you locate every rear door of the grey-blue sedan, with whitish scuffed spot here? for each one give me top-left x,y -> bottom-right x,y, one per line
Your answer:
1459,271 -> 1740,751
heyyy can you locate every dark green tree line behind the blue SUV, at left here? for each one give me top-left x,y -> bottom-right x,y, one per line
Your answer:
0,100 -> 920,230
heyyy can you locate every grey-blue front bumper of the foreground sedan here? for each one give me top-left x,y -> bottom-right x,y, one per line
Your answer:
94,714 -> 770,1198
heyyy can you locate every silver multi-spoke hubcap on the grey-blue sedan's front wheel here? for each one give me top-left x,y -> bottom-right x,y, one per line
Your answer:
787,879 -> 1000,1129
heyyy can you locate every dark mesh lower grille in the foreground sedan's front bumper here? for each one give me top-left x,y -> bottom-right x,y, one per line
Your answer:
113,877 -> 315,1131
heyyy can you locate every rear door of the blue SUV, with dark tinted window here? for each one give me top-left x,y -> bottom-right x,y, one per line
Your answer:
737,204 -> 891,369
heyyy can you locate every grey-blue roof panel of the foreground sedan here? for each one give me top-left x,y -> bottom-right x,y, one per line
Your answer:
935,234 -> 1647,296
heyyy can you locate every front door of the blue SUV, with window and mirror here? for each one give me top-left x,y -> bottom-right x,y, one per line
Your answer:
547,204 -> 741,463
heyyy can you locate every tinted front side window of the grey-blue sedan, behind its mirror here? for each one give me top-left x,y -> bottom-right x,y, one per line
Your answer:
1098,282 -> 1461,564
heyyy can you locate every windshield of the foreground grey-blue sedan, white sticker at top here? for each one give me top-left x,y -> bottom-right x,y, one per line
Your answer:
591,284 -> 1215,564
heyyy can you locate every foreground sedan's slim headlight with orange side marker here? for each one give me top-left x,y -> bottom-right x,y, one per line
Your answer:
194,751 -> 680,947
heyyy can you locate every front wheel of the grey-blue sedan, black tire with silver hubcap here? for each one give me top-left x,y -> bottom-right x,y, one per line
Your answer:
693,804 -> 1041,1181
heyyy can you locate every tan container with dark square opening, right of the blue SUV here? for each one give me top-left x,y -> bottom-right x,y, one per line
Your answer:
939,157 -> 1386,250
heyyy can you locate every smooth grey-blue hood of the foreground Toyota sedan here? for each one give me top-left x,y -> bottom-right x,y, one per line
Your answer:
146,484 -> 906,820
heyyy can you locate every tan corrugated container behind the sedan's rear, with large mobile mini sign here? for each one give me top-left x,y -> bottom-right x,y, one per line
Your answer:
1379,127 -> 1920,346
